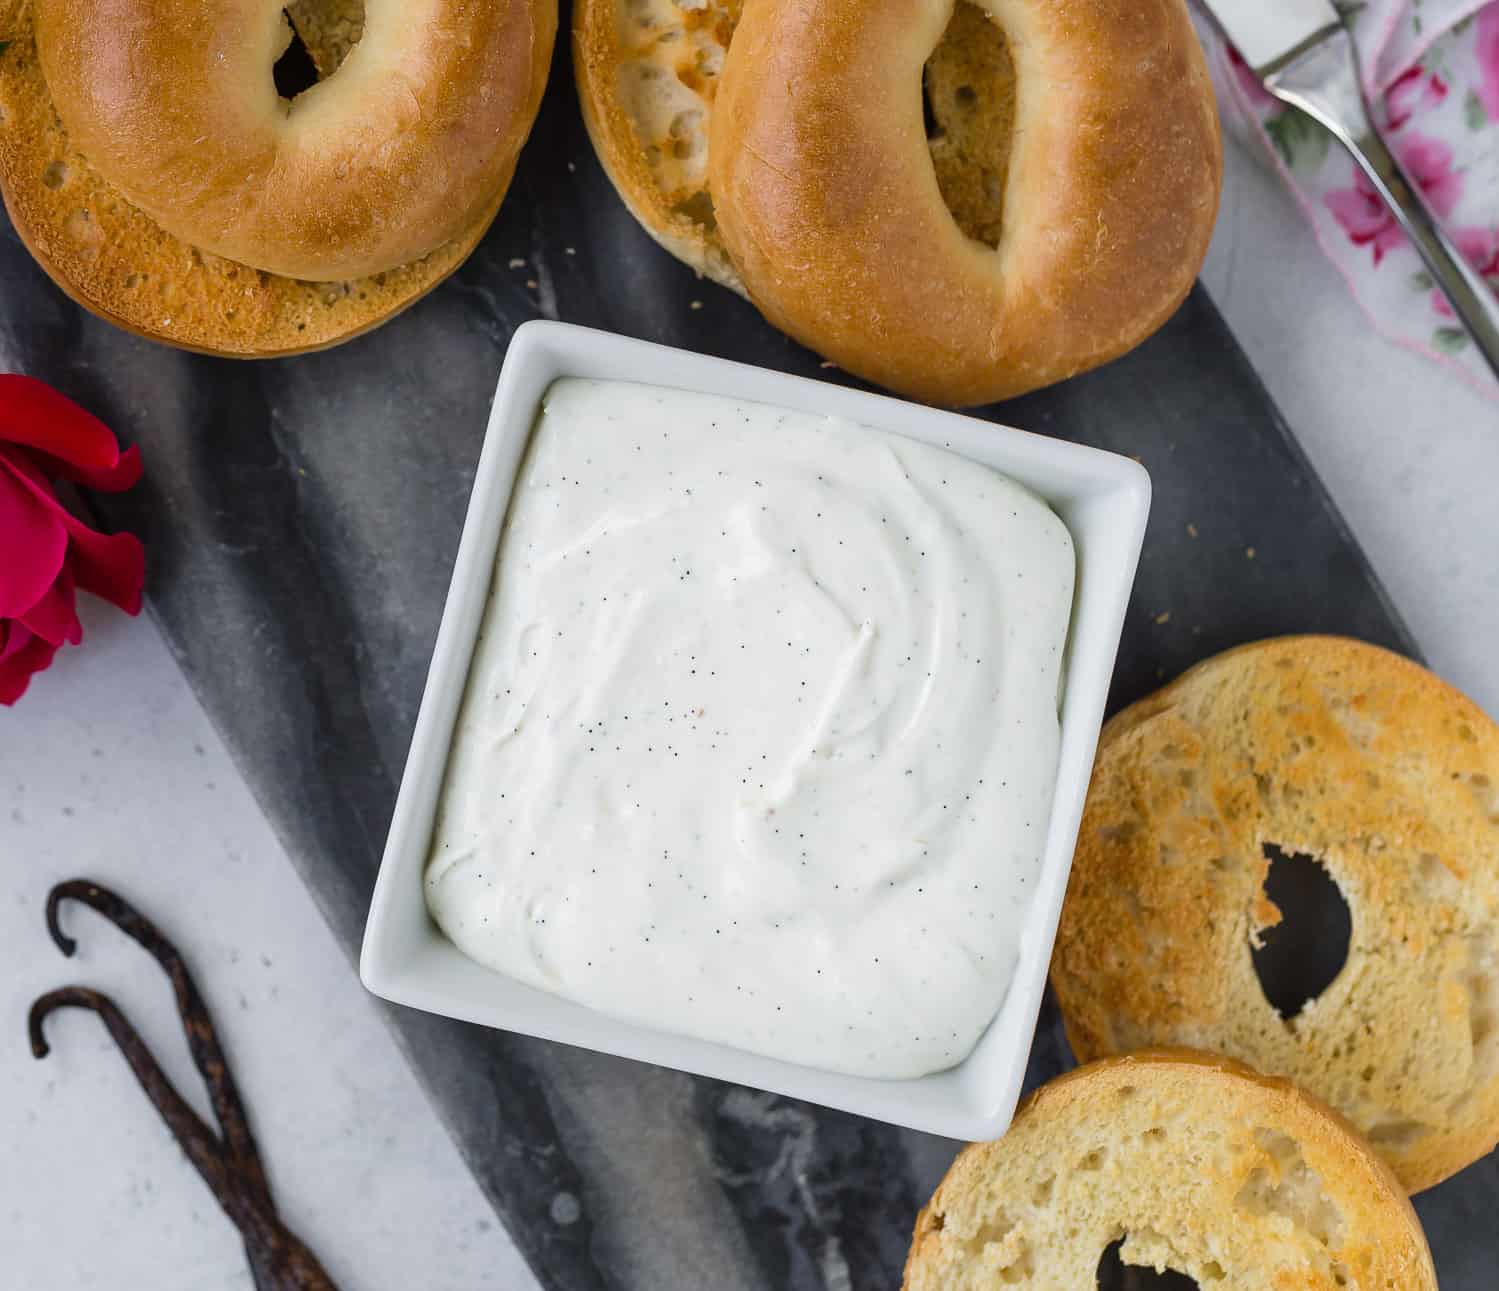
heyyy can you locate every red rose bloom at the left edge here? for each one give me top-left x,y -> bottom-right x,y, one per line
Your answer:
0,373 -> 145,705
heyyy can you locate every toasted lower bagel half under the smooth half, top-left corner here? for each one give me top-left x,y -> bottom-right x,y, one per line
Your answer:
0,0 -> 550,357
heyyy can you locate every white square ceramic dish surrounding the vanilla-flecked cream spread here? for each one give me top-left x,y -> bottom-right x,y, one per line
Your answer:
360,322 -> 1150,1140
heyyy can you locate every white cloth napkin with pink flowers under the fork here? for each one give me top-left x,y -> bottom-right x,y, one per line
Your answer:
1198,0 -> 1499,397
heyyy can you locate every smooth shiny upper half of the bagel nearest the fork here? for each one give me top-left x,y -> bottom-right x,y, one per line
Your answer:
708,0 -> 1222,405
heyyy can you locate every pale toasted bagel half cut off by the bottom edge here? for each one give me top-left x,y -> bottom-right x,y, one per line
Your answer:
904,1053 -> 1436,1291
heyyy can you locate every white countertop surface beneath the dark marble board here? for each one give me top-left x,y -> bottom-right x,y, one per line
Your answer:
0,131 -> 1499,1291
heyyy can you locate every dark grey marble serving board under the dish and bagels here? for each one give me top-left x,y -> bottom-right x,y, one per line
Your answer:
0,27 -> 1499,1291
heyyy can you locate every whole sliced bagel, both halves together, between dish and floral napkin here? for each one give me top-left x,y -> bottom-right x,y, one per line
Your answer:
573,0 -> 1222,405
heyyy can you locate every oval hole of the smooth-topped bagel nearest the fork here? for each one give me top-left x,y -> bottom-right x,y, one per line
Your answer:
922,0 -> 1015,247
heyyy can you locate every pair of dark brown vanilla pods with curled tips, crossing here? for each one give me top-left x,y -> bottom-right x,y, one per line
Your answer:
28,880 -> 336,1291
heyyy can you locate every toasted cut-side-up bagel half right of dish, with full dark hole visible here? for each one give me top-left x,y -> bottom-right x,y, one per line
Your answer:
1051,637 -> 1499,1192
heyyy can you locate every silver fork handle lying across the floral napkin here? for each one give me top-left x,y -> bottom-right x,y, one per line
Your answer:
1265,28 -> 1499,378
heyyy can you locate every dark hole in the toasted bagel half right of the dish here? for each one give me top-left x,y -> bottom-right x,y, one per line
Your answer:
1250,843 -> 1354,1021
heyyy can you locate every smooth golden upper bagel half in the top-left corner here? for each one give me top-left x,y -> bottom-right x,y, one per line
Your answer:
33,0 -> 556,282
